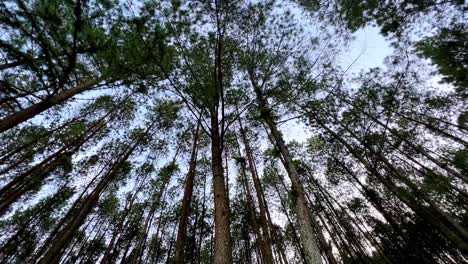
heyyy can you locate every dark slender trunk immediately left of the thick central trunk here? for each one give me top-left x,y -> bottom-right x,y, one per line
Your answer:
175,121 -> 200,264
